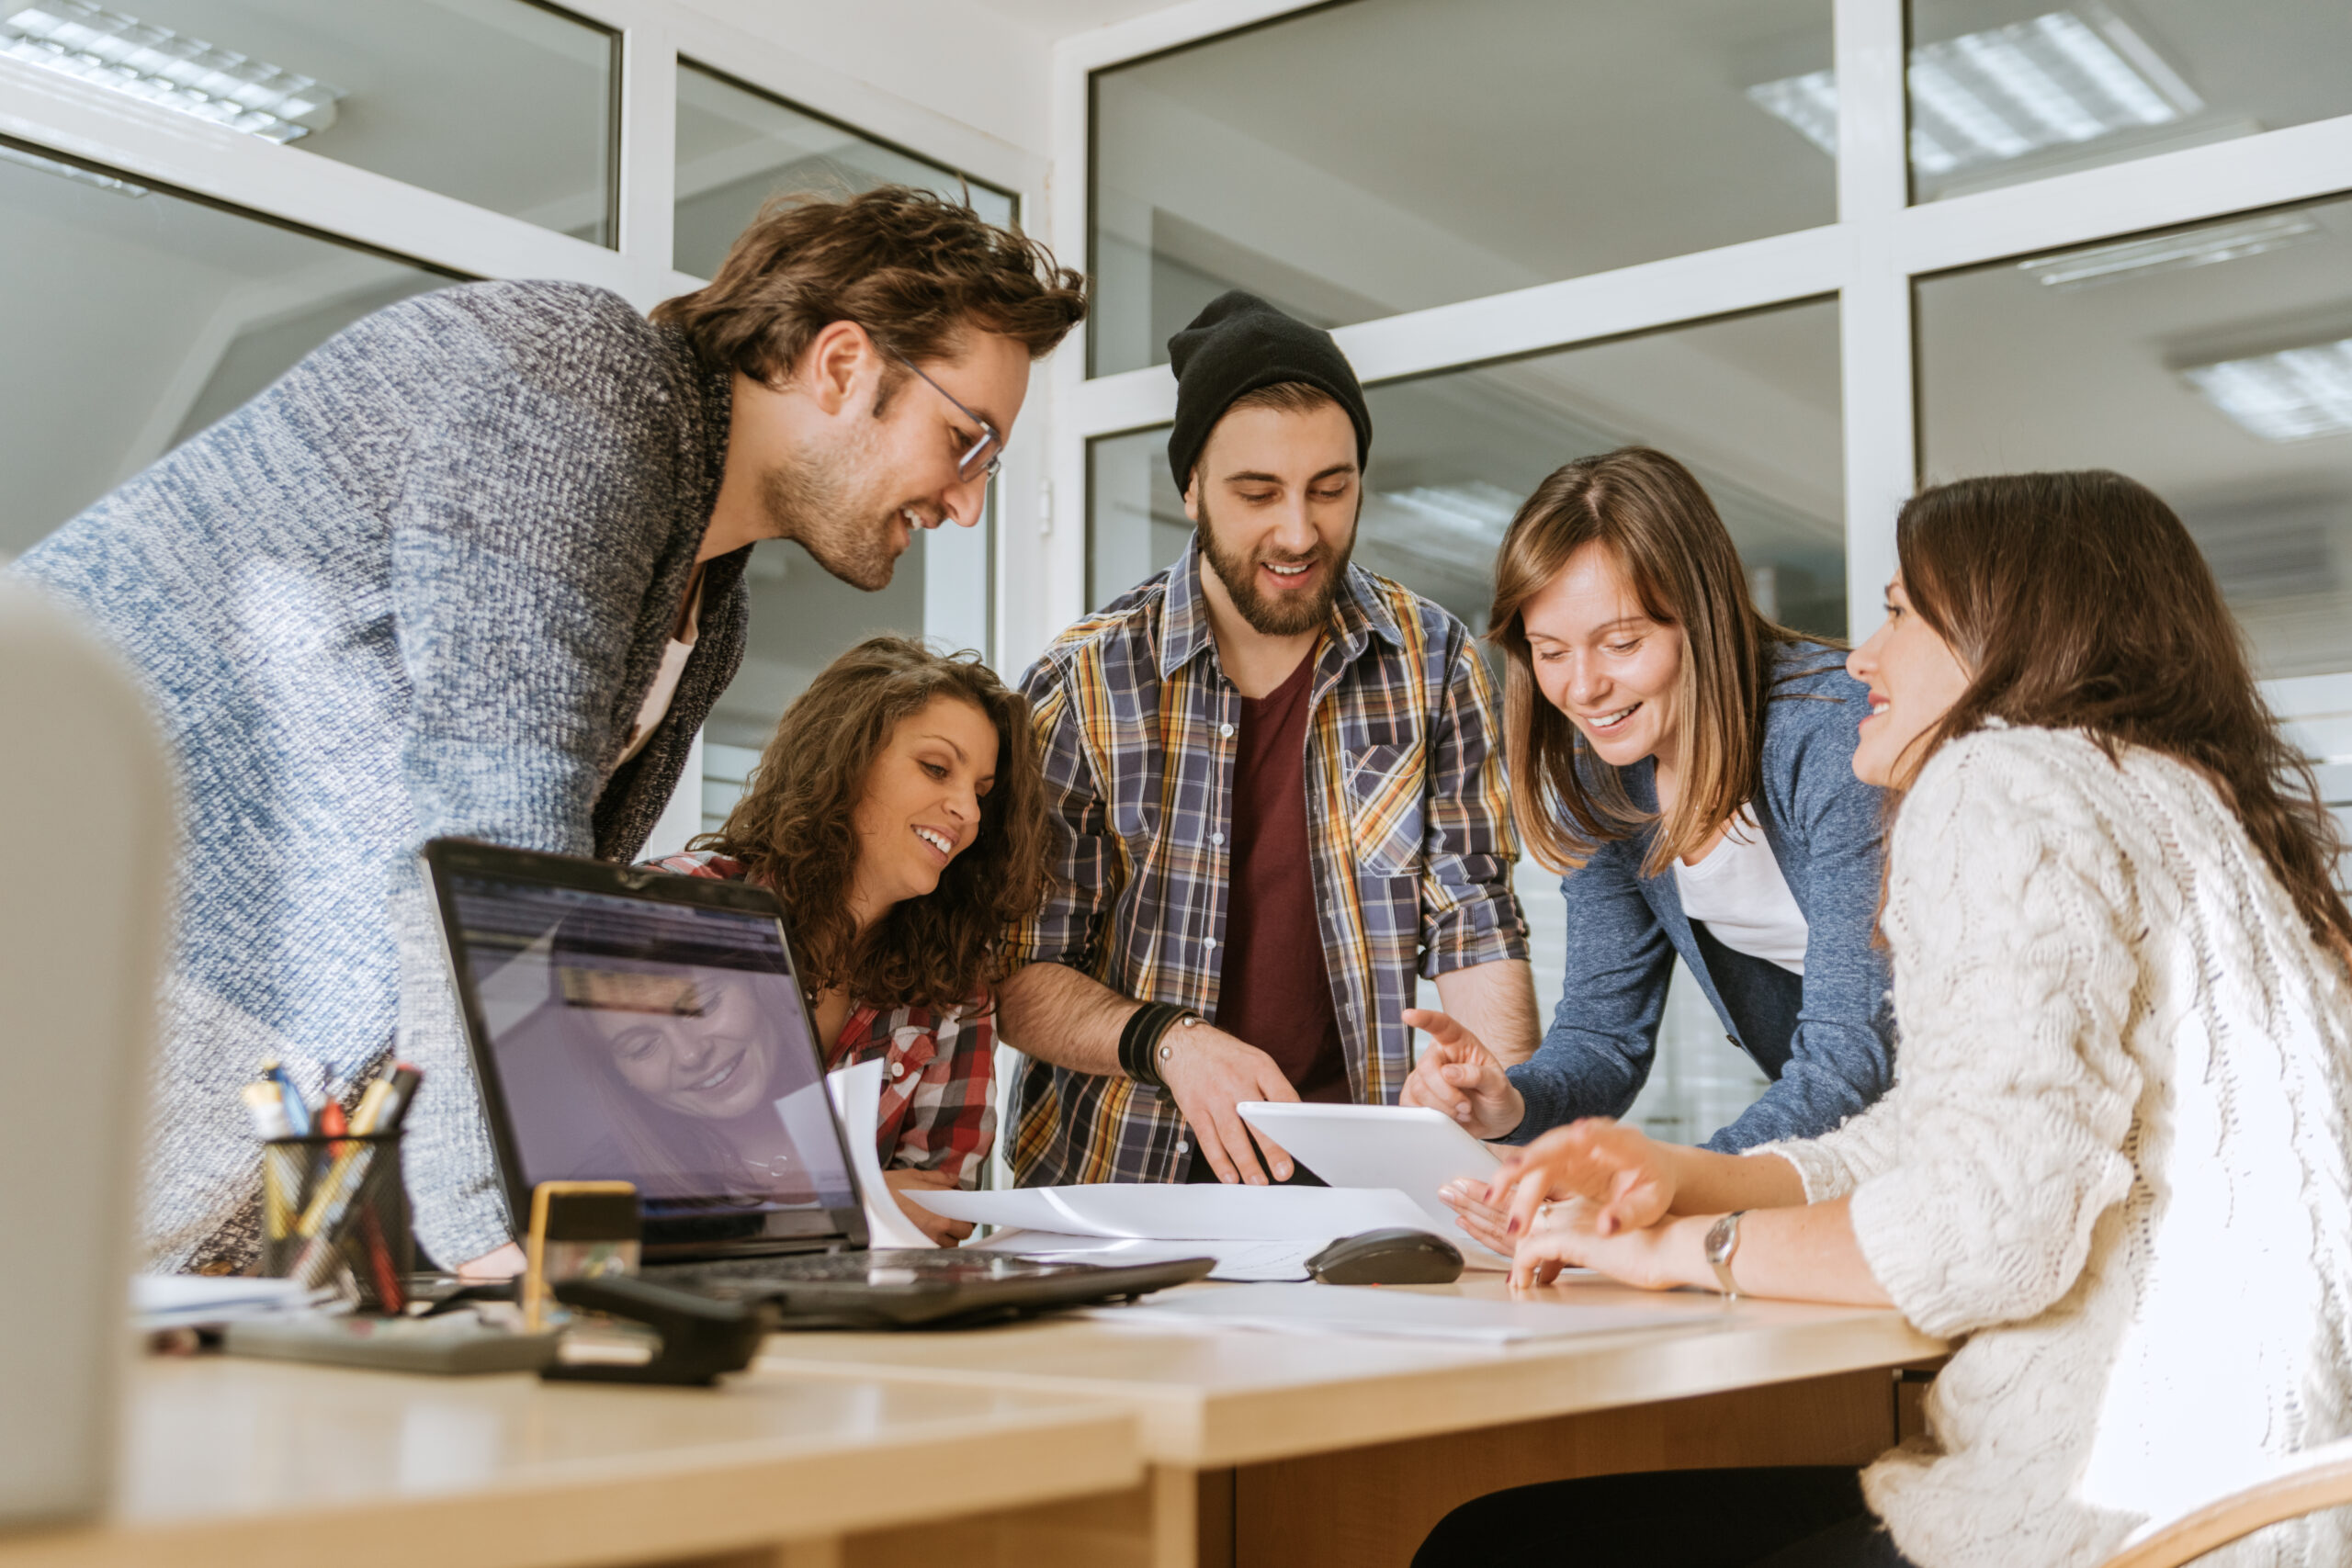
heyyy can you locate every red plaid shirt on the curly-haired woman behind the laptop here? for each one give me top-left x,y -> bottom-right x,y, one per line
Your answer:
651,849 -> 997,1187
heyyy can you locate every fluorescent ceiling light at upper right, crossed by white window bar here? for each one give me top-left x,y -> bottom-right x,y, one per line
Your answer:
1747,0 -> 2204,174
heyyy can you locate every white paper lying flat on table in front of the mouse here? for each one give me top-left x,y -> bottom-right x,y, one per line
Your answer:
1096,1283 -> 1713,1345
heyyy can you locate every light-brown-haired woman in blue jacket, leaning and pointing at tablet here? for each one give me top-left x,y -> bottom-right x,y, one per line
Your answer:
1404,446 -> 1891,1251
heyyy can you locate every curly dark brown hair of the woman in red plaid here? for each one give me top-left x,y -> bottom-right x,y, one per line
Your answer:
694,637 -> 1045,1009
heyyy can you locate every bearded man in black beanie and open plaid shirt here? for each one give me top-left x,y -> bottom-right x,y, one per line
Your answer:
1000,291 -> 1536,1185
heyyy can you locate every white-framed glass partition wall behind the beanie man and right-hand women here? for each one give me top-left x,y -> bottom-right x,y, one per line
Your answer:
1056,0 -> 2352,1138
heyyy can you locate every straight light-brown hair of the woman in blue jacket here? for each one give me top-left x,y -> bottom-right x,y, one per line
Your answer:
1487,446 -> 1820,877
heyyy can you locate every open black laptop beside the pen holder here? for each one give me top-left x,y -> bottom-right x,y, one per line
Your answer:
424,840 -> 1214,1328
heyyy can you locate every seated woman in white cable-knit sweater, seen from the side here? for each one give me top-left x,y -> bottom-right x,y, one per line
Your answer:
1416,472 -> 2352,1568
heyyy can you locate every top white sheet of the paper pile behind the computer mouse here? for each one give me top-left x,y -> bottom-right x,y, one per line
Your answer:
912,1182 -> 1430,1244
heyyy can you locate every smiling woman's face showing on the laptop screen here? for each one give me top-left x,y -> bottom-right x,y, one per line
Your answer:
562,968 -> 778,1122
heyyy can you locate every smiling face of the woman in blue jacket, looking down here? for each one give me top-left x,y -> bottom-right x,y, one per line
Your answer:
1520,541 -> 1681,769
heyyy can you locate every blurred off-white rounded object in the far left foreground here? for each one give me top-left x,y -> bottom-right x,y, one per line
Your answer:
0,581 -> 174,1528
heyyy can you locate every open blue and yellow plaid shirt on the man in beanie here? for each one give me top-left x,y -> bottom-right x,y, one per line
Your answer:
1007,541 -> 1526,1185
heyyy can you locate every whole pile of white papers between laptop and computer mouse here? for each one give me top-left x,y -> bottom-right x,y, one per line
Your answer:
912,1182 -> 1430,1279
